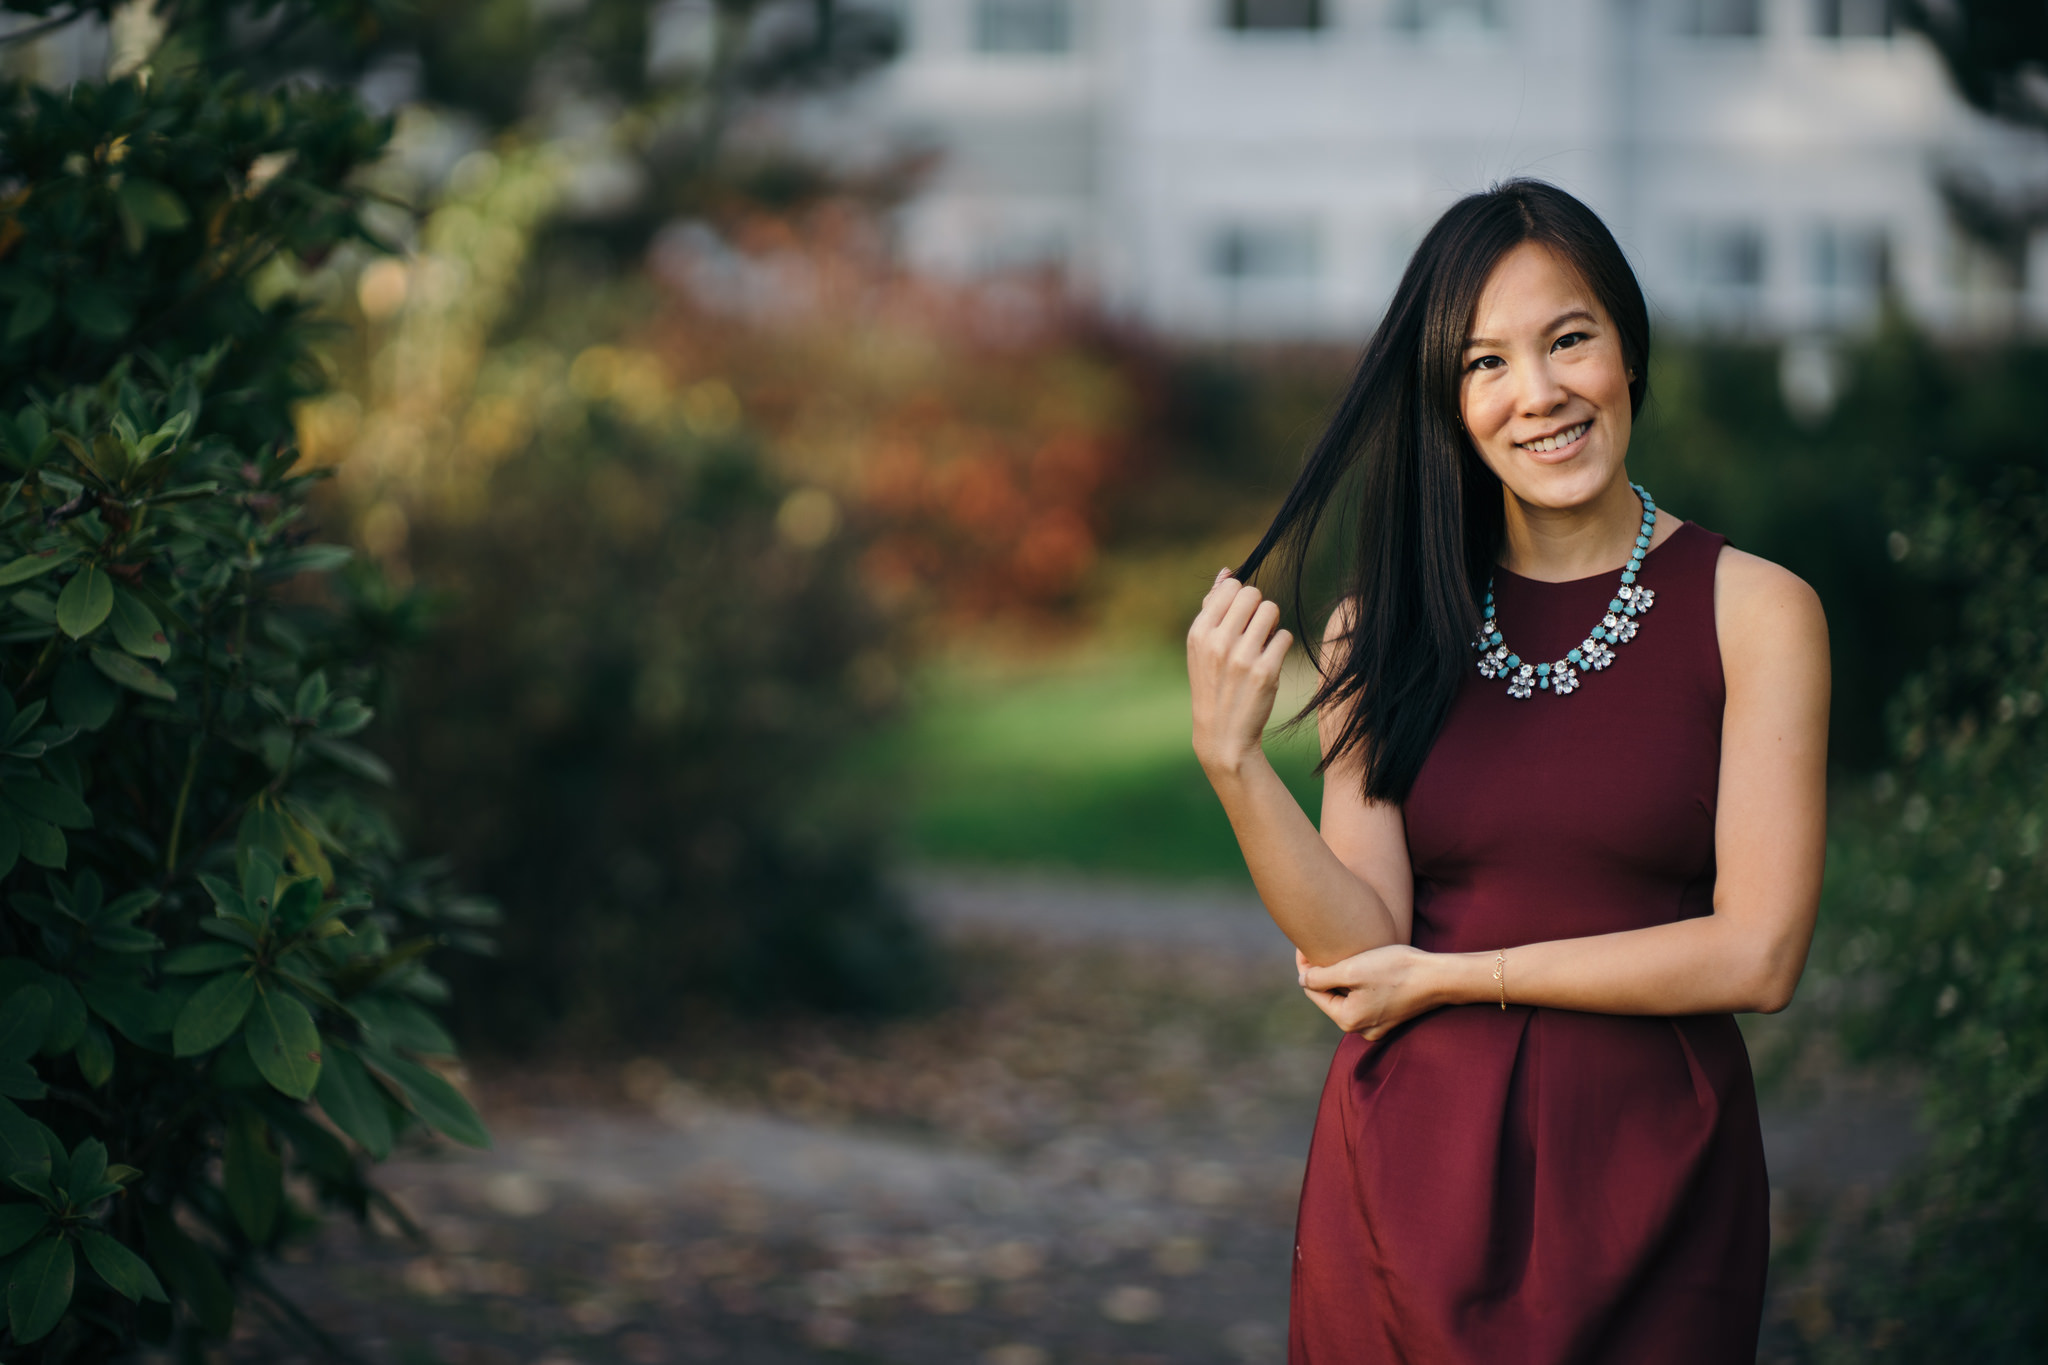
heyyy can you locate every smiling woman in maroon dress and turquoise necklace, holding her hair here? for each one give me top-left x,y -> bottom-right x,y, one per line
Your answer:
1188,180 -> 1829,1365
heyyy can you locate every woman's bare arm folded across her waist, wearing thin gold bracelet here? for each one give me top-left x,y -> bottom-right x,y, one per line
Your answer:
1303,551 -> 1829,1038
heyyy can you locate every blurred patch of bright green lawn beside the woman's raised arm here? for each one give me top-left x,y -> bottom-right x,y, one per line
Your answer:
862,655 -> 1321,878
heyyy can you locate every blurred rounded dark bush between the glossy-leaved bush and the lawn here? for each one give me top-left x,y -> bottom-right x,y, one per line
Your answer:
391,384 -> 938,1048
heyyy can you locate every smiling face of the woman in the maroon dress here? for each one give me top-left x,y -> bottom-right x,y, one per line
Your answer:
1458,241 -> 1634,512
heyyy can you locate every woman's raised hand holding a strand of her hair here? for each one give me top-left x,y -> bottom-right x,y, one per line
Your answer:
1188,569 -> 1294,776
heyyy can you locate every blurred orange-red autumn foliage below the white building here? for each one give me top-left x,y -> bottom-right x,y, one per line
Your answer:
641,205 -> 1147,626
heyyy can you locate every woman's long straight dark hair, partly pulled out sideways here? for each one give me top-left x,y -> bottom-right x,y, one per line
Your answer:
1237,180 -> 1651,802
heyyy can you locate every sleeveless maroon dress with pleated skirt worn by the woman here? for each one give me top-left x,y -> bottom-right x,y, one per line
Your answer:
1288,524 -> 1769,1365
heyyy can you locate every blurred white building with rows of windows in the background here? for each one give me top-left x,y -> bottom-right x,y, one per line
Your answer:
860,0 -> 2048,338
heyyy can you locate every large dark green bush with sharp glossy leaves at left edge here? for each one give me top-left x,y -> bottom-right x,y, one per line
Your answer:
0,48 -> 487,1361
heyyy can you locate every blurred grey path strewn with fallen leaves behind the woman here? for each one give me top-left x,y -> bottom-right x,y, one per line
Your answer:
231,872 -> 1913,1365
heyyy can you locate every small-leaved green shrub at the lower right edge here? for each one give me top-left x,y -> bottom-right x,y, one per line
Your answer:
1777,467 -> 2048,1363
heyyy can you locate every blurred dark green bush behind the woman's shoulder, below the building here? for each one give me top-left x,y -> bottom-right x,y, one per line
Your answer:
1630,325 -> 2048,772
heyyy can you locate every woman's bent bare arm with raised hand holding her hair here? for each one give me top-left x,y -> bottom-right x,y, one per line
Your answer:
1188,575 -> 1413,962
